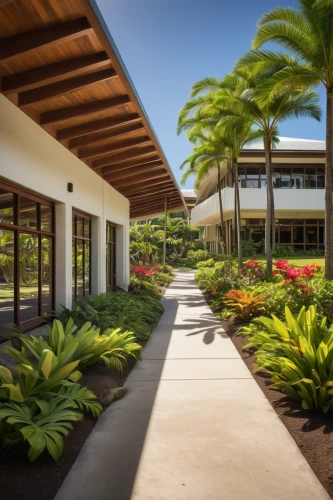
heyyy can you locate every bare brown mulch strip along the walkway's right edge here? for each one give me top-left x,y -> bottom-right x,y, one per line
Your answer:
220,314 -> 333,499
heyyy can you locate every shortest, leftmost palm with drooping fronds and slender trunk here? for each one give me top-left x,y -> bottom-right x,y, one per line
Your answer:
180,127 -> 228,253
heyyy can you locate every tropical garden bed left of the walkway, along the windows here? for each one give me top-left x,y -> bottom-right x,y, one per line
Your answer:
0,266 -> 173,500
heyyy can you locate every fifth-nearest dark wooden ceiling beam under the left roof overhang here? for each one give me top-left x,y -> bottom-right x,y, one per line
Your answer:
57,113 -> 140,140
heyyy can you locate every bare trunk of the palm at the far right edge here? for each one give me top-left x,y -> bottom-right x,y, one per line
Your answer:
325,90 -> 333,280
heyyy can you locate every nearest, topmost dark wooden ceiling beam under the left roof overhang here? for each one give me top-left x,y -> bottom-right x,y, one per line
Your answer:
0,17 -> 92,62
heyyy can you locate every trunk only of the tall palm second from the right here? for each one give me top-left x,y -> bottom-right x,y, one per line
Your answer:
264,136 -> 275,276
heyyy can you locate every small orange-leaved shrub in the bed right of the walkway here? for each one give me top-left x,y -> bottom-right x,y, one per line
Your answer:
223,290 -> 266,321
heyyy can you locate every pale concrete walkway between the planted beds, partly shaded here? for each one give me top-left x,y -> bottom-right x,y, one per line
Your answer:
56,272 -> 330,500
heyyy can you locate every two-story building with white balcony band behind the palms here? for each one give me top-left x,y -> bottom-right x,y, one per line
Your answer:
191,137 -> 325,253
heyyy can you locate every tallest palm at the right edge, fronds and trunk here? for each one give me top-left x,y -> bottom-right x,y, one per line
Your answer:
233,0 -> 333,279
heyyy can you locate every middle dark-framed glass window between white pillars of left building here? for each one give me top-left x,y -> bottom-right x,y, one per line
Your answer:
72,212 -> 91,301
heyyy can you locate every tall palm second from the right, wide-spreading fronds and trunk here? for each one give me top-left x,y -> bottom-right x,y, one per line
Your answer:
178,72 -> 320,275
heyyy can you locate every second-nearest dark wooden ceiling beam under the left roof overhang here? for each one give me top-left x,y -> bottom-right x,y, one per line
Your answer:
1,52 -> 110,95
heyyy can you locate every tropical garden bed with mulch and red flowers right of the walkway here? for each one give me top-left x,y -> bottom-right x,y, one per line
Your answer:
196,259 -> 333,498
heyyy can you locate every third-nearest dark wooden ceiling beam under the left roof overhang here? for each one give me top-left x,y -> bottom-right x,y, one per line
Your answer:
18,68 -> 118,107
